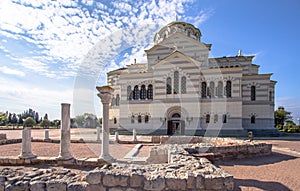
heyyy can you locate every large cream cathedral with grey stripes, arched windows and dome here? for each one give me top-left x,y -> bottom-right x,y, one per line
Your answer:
107,21 -> 276,136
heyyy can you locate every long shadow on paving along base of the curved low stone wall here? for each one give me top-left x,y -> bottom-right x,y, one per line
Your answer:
215,151 -> 298,166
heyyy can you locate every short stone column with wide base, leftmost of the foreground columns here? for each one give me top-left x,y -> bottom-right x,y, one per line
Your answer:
19,127 -> 36,159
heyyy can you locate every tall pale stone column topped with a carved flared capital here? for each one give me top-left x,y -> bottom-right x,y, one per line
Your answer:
96,86 -> 114,161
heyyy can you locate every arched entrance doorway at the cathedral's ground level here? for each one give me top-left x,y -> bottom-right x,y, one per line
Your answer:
167,113 -> 184,135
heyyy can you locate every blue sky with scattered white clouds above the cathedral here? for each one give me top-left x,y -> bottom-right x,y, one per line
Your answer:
0,0 -> 300,122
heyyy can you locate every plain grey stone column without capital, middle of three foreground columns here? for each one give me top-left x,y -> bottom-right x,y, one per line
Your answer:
57,103 -> 73,160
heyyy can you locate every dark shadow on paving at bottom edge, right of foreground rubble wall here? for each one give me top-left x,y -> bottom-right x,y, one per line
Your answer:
234,179 -> 291,191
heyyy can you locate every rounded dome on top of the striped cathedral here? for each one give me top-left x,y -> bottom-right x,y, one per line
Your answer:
154,21 -> 201,44
